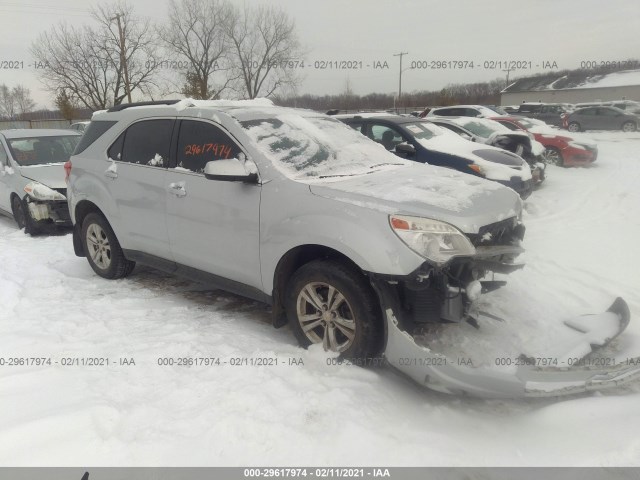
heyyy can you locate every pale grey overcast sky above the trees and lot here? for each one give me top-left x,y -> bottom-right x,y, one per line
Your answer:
0,0 -> 640,107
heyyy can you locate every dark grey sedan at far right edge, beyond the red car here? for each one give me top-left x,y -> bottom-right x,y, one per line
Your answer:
563,106 -> 640,132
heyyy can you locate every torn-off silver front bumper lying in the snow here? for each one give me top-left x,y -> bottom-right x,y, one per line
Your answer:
380,284 -> 640,398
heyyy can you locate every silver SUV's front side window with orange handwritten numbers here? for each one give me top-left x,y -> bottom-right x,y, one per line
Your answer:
176,120 -> 241,173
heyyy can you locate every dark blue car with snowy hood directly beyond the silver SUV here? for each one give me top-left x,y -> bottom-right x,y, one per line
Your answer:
336,113 -> 533,198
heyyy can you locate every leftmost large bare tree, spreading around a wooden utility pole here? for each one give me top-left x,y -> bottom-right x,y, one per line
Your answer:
31,3 -> 159,110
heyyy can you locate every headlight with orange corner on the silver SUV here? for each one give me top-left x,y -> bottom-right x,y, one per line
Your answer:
389,215 -> 476,265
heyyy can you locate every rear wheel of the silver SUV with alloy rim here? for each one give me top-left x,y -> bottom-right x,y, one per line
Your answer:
82,213 -> 136,279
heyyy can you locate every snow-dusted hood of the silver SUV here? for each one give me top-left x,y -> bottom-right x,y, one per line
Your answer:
309,164 -> 522,233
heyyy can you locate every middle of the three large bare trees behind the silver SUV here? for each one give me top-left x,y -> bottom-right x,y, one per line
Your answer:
160,0 -> 233,99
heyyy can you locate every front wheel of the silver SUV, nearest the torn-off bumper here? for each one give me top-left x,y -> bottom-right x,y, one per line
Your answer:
285,260 -> 383,360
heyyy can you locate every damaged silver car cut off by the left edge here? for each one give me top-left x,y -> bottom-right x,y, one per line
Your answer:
0,129 -> 82,235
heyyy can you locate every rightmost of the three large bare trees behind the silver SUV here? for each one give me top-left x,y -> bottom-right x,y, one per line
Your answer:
227,6 -> 303,98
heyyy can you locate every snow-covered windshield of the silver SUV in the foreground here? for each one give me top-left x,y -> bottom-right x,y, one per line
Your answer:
241,114 -> 411,180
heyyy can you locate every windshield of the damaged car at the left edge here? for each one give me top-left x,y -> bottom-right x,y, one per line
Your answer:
8,135 -> 81,166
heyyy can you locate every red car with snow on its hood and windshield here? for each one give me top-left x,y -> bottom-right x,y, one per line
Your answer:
492,117 -> 598,167
